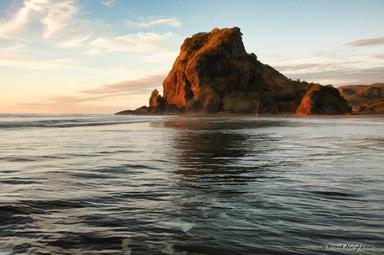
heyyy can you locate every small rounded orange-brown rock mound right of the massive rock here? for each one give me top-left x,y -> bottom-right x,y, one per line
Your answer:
296,84 -> 352,115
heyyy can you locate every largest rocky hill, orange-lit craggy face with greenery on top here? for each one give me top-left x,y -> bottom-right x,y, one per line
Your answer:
163,27 -> 306,113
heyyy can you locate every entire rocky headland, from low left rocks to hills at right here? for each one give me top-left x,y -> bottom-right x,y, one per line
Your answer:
116,27 -> 384,115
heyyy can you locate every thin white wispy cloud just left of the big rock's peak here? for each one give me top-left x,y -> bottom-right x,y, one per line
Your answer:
88,32 -> 174,53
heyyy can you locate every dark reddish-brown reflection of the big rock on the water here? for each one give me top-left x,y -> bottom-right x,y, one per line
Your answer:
169,119 -> 254,175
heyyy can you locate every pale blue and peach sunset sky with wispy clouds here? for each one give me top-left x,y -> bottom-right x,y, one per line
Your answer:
0,0 -> 384,114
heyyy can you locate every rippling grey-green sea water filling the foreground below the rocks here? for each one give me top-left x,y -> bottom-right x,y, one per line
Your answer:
0,115 -> 384,255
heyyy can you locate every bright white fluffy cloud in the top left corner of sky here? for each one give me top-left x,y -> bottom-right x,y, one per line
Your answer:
0,0 -> 78,39
